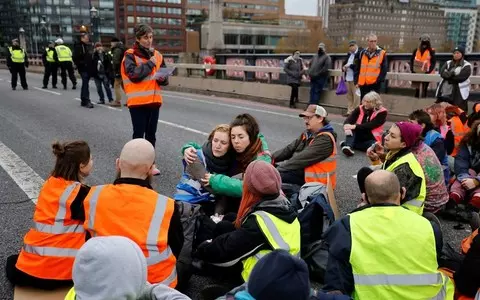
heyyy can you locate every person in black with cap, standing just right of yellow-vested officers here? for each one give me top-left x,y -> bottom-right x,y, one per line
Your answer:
73,32 -> 93,108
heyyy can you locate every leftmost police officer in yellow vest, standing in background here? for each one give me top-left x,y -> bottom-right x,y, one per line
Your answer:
7,39 -> 28,90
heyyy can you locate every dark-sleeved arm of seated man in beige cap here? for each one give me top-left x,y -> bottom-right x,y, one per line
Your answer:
278,135 -> 334,171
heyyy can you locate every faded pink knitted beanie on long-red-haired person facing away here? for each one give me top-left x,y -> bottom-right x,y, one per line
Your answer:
243,160 -> 282,195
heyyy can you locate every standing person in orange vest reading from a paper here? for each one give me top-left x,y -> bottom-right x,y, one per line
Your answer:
121,24 -> 168,175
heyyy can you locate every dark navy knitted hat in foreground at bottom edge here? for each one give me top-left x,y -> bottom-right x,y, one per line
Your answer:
247,250 -> 310,300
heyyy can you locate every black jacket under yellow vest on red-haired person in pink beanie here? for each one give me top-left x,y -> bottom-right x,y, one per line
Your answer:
194,196 -> 300,267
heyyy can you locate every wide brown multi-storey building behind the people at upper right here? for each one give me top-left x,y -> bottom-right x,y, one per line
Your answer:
328,0 -> 446,51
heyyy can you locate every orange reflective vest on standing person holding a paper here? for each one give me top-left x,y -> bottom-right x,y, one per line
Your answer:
121,49 -> 163,107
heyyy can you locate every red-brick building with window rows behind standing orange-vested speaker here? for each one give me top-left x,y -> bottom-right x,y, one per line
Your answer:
115,0 -> 186,53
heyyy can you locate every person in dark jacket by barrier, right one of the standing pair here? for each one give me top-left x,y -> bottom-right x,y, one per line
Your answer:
308,43 -> 332,104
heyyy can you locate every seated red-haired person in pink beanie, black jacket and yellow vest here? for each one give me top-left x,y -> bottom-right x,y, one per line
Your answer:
194,161 -> 300,290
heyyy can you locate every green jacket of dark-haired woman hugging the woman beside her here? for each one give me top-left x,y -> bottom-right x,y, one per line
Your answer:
181,133 -> 272,198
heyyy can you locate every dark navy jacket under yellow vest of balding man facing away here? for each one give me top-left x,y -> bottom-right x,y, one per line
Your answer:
323,204 -> 443,295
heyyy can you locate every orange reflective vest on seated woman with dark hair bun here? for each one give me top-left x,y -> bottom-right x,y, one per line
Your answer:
16,177 -> 85,280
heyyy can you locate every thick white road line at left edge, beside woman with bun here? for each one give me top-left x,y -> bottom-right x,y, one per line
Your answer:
0,142 -> 44,204
